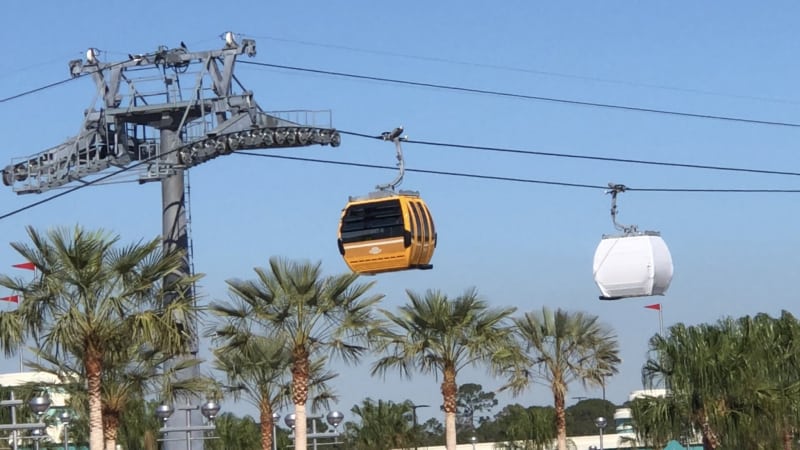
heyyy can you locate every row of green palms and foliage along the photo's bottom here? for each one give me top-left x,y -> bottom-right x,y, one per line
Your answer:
0,226 -> 797,450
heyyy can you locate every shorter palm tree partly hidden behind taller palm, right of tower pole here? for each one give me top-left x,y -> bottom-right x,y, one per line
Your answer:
214,326 -> 336,450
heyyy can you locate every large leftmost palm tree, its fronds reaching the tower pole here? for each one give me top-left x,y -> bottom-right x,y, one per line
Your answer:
0,226 -> 196,450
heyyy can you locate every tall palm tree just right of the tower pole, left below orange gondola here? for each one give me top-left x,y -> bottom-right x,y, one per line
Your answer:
211,257 -> 382,450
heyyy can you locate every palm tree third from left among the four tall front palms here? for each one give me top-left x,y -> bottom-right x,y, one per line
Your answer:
372,289 -> 522,450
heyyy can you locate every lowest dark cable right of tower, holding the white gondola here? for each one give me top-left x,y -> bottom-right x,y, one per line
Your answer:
234,151 -> 800,193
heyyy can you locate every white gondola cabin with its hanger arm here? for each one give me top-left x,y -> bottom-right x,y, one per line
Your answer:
593,183 -> 673,300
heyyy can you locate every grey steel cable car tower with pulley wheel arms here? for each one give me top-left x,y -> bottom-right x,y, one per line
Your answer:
1,32 -> 340,450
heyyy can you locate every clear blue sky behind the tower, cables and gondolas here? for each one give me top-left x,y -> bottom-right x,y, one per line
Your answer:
0,0 -> 800,426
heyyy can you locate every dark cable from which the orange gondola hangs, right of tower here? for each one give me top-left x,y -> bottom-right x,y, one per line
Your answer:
339,130 -> 800,177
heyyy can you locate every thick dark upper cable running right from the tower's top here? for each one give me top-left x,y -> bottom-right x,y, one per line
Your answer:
240,61 -> 800,128
